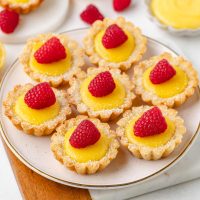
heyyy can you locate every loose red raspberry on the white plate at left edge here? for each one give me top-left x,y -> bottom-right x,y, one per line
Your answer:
0,10 -> 19,33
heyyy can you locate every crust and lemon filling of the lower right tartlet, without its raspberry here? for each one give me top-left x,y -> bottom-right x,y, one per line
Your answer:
116,106 -> 186,160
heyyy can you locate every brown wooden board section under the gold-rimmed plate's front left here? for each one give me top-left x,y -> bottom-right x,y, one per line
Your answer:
4,143 -> 91,200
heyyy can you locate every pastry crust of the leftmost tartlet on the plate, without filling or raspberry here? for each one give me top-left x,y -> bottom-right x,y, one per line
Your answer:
3,83 -> 71,136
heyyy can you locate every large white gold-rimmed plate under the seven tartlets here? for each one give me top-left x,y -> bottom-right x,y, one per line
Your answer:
0,29 -> 200,189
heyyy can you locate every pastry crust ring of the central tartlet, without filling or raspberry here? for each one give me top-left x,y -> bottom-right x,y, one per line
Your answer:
68,67 -> 135,122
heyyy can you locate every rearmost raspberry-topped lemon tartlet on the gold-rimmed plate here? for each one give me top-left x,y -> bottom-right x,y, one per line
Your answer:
83,17 -> 147,70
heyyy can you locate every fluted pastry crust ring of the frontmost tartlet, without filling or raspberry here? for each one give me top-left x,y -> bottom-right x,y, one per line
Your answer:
51,115 -> 119,174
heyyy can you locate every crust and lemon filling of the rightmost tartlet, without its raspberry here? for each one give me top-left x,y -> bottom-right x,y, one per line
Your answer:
133,53 -> 198,107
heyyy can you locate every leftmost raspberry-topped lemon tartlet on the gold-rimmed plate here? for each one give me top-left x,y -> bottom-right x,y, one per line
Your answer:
4,83 -> 71,136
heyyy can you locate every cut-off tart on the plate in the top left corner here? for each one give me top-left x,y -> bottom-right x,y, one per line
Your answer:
0,0 -> 43,14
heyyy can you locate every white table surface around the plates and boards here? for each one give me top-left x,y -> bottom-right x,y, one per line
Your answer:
0,0 -> 200,200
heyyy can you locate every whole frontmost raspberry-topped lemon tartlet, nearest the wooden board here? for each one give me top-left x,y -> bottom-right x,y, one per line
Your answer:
51,115 -> 119,174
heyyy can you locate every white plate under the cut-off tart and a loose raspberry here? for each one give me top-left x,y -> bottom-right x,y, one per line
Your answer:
0,0 -> 69,43
